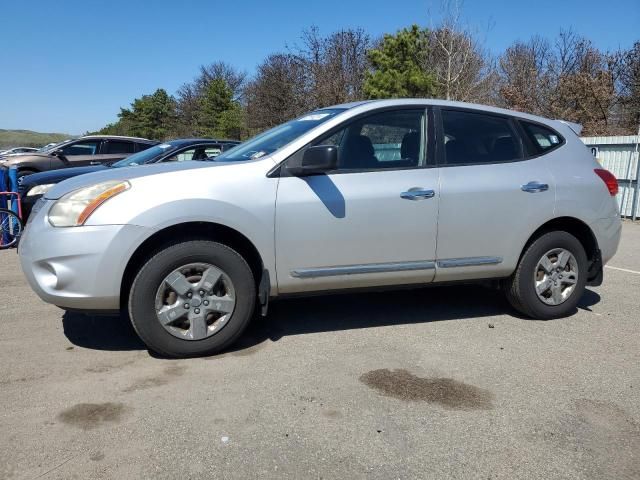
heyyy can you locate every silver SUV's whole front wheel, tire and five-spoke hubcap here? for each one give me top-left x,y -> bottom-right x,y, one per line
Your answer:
129,240 -> 256,357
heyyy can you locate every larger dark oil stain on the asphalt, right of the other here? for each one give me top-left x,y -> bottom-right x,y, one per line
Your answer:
360,368 -> 493,410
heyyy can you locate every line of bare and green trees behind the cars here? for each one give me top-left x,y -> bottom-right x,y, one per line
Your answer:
99,14 -> 640,140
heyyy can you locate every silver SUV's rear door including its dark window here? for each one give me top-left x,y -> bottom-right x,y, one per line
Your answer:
435,108 -> 555,281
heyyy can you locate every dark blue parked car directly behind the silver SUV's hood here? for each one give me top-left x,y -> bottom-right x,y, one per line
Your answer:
18,138 -> 240,219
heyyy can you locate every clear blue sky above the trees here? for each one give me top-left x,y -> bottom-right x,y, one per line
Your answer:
0,0 -> 640,134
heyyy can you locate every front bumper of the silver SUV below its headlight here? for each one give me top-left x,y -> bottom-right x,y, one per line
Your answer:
18,201 -> 149,310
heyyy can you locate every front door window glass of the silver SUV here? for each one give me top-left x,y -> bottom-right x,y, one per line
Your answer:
314,109 -> 426,170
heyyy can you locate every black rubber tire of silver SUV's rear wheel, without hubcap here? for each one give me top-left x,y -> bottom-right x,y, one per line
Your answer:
503,231 -> 587,320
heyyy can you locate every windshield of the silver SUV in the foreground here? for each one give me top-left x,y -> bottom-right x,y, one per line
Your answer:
216,108 -> 345,162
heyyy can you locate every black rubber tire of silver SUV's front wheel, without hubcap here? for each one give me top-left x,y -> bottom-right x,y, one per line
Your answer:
129,240 -> 257,358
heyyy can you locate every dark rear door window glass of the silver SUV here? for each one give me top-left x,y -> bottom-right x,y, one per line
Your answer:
442,110 -> 522,165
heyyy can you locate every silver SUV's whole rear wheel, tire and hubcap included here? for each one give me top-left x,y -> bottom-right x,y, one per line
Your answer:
504,231 -> 587,320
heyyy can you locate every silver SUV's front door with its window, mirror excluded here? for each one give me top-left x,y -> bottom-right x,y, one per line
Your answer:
275,108 -> 439,293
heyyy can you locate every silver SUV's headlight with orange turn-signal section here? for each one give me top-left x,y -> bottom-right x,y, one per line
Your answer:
49,180 -> 131,227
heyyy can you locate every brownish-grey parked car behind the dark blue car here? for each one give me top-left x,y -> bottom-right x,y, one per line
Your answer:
0,135 -> 159,177
